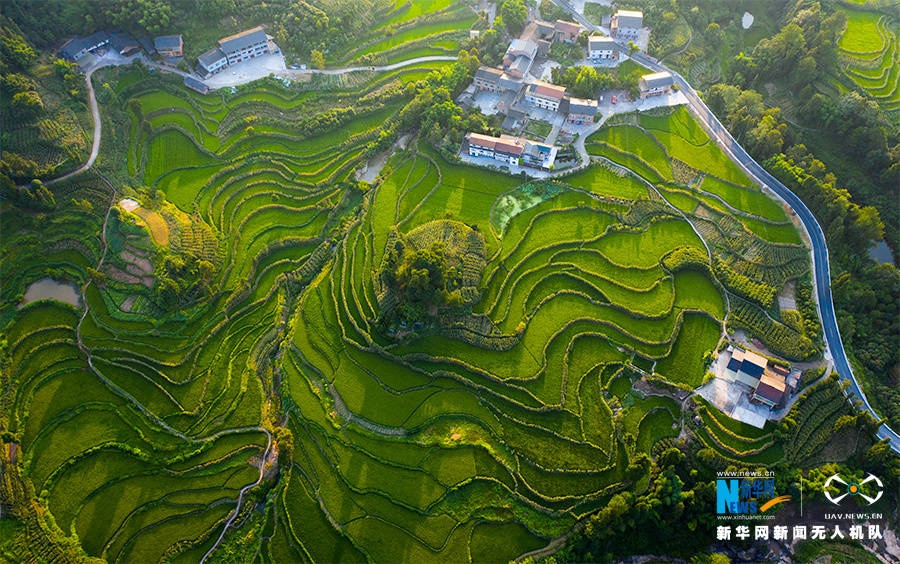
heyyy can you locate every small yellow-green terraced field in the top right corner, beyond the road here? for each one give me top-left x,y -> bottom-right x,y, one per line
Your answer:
838,9 -> 900,122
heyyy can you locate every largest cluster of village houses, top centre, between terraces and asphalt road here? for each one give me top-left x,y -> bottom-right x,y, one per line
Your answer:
461,10 -> 674,170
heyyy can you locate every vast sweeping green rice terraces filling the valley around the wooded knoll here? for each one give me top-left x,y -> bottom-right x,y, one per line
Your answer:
2,59 -> 808,562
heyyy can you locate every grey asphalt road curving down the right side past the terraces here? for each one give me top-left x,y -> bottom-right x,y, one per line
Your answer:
553,0 -> 900,452
